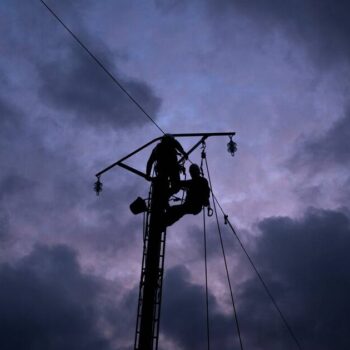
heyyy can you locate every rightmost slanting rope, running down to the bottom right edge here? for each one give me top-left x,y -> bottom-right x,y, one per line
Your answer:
212,197 -> 302,350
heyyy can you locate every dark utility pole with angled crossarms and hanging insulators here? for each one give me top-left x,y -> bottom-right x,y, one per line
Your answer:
95,132 -> 236,350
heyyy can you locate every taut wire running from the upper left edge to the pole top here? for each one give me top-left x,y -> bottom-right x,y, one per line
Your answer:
39,0 -> 165,134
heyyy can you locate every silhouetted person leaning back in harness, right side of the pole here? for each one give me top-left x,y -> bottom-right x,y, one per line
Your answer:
165,164 -> 210,226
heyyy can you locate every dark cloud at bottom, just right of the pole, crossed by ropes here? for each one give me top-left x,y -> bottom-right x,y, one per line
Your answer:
161,266 -> 234,350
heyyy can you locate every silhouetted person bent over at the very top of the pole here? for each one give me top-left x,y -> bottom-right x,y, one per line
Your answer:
146,134 -> 187,196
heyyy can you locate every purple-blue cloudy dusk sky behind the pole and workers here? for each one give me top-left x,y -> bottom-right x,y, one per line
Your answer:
0,0 -> 350,350
